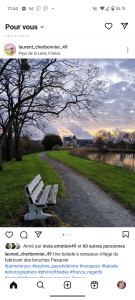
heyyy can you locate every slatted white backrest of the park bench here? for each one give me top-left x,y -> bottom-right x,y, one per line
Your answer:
25,174 -> 44,203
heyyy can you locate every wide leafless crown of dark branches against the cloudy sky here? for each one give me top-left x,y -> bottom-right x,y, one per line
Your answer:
0,59 -> 106,169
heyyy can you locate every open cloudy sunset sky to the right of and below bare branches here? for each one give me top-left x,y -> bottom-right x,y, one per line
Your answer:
37,59 -> 135,139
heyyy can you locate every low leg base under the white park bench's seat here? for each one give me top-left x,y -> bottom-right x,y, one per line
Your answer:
24,205 -> 52,221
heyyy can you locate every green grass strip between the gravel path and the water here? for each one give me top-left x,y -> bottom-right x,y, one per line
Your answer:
47,151 -> 135,212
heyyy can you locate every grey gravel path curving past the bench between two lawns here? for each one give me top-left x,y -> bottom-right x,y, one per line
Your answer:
39,153 -> 135,227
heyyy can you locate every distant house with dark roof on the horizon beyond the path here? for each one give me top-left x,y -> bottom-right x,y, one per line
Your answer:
63,135 -> 93,147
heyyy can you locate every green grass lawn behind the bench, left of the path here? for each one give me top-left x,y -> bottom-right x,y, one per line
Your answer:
0,153 -> 63,227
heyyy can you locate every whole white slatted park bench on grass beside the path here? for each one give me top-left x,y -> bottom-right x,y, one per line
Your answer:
24,174 -> 58,220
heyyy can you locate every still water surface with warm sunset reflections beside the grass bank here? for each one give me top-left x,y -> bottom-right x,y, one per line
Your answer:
88,152 -> 135,172
